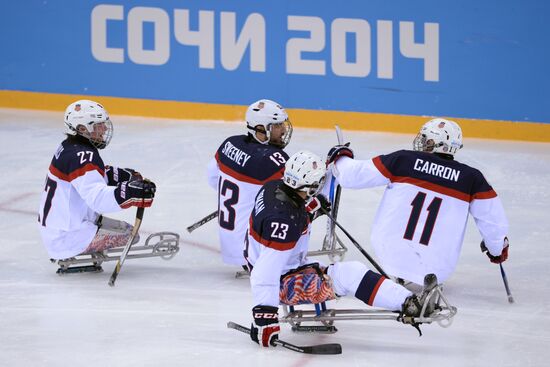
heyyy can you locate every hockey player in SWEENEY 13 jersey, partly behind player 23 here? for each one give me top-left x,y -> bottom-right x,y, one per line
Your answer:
208,99 -> 292,269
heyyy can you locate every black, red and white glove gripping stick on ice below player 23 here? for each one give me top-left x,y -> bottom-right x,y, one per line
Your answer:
250,305 -> 281,347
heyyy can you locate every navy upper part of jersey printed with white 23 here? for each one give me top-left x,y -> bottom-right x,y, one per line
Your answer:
251,180 -> 309,243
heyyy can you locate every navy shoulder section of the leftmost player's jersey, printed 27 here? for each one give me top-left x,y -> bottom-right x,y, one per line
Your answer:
51,139 -> 105,175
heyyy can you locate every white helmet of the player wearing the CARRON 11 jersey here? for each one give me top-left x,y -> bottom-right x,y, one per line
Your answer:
413,118 -> 462,155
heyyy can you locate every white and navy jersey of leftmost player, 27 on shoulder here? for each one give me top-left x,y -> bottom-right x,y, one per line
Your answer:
38,140 -> 121,259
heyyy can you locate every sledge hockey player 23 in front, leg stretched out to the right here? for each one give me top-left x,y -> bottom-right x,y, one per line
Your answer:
244,151 -> 444,347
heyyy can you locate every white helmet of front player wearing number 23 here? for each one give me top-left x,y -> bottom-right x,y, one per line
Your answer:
283,150 -> 327,197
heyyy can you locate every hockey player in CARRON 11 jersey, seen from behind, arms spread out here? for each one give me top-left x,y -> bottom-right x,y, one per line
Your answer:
327,118 -> 508,284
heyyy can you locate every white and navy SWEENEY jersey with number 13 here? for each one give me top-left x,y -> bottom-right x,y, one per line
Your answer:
208,135 -> 288,266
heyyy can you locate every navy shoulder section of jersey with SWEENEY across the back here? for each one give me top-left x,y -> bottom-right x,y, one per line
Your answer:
216,135 -> 288,182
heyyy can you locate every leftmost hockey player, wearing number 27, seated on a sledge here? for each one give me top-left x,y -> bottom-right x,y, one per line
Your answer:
38,100 -> 156,259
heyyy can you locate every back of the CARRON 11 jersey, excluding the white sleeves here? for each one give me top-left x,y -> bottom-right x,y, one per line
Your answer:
371,150 -> 496,284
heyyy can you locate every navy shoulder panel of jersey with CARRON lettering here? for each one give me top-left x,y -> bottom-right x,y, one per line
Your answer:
375,150 -> 492,195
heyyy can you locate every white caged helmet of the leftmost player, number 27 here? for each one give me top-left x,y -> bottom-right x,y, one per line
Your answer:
65,99 -> 113,149
